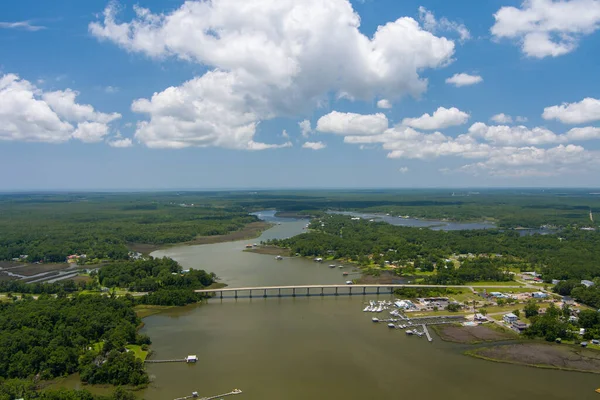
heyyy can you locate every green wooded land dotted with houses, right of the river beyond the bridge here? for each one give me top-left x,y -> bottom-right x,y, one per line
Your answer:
270,215 -> 600,290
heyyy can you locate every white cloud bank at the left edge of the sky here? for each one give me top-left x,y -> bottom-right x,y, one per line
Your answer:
0,74 -> 121,143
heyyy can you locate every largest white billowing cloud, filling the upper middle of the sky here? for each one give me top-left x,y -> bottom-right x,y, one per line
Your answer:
89,0 -> 454,149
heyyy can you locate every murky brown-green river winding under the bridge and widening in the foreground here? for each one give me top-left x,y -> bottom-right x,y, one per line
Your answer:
70,213 -> 600,400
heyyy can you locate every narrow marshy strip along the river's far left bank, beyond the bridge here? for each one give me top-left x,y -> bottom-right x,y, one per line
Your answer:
127,221 -> 273,254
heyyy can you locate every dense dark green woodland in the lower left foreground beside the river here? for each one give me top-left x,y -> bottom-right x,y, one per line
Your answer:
0,294 -> 150,386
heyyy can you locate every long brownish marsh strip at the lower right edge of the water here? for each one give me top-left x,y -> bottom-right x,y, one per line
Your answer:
465,341 -> 600,374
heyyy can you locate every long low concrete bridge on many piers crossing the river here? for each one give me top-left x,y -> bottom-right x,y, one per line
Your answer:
195,284 -> 522,299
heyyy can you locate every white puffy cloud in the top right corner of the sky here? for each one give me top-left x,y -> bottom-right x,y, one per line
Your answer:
491,0 -> 600,58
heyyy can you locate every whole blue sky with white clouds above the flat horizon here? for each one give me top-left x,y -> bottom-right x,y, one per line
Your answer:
0,0 -> 600,190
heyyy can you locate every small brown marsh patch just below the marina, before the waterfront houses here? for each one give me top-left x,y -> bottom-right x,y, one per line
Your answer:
431,324 -> 518,344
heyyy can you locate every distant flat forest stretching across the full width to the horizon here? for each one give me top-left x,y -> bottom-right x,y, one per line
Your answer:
0,189 -> 600,262
